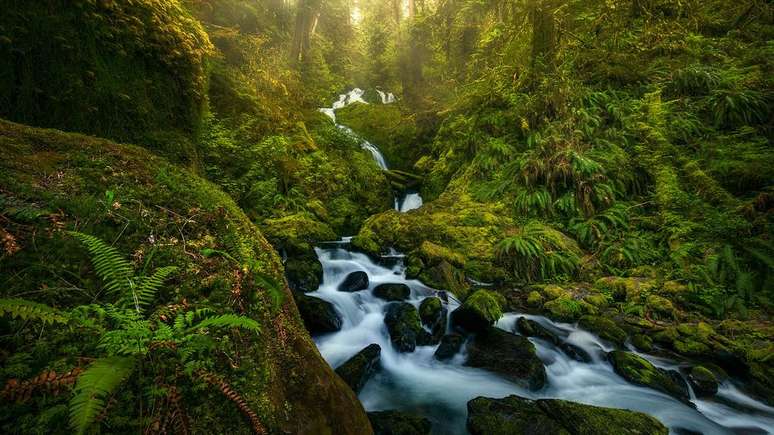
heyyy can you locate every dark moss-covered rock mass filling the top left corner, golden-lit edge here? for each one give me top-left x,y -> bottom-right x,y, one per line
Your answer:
0,0 -> 212,165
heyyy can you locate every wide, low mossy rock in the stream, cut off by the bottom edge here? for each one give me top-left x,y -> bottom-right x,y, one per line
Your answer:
468,396 -> 669,435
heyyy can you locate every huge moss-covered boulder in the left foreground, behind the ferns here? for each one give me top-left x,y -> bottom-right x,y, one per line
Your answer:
0,121 -> 371,434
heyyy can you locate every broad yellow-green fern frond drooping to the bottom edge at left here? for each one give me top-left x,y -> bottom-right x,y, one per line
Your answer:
70,357 -> 135,434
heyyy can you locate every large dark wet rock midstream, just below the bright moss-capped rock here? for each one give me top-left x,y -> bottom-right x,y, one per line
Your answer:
465,326 -> 546,390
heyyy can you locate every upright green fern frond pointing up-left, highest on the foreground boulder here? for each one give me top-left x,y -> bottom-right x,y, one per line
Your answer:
69,231 -> 134,293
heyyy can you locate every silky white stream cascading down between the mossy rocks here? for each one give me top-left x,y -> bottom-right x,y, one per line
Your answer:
308,89 -> 774,435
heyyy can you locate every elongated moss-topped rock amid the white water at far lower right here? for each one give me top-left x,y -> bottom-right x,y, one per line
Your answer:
607,350 -> 689,402
